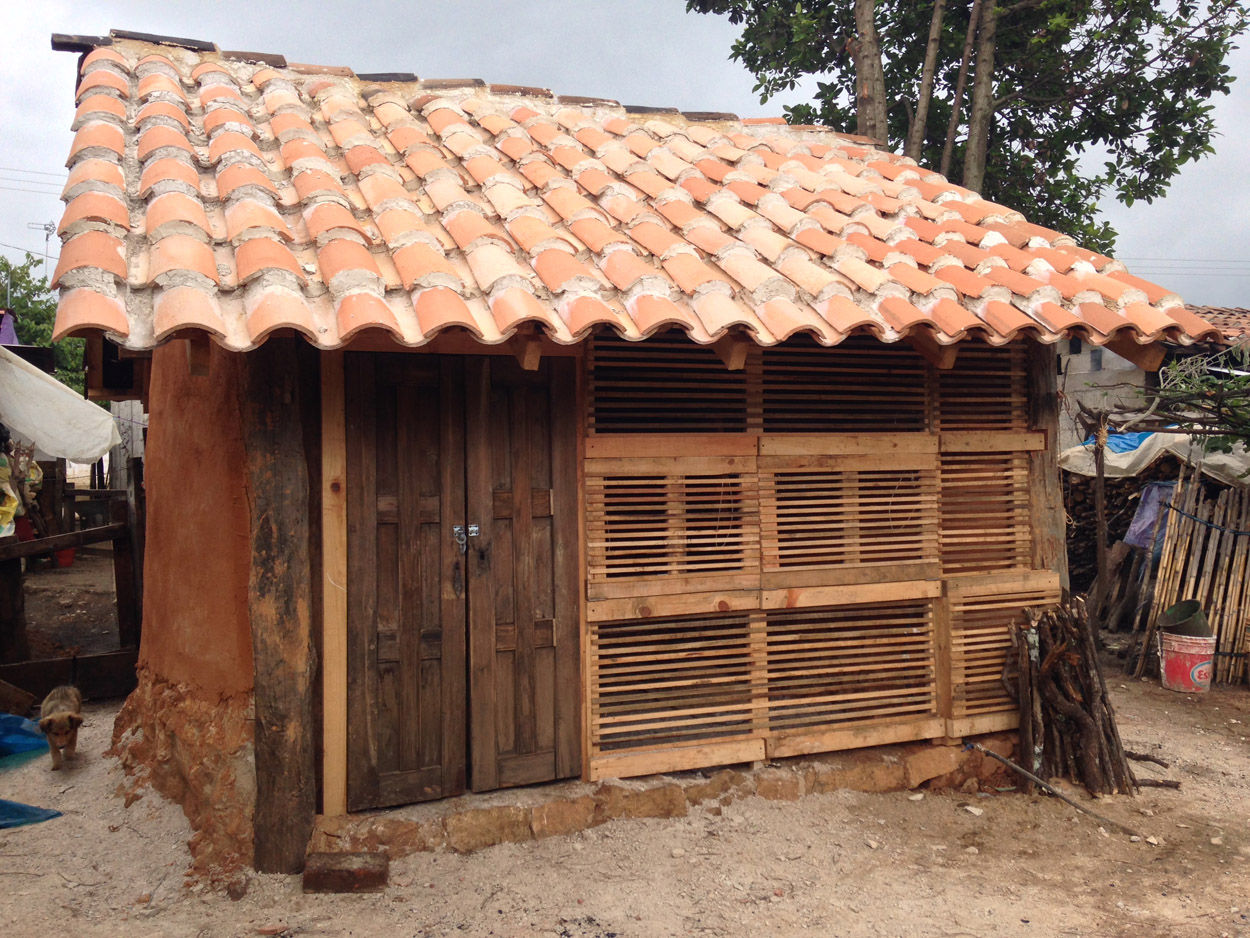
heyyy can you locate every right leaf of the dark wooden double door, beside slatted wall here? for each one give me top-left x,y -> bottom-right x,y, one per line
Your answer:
466,359 -> 580,790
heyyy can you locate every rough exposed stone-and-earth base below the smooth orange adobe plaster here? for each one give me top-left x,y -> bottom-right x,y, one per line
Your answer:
110,668 -> 256,883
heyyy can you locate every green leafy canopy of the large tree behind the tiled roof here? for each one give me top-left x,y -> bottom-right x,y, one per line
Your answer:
686,0 -> 1250,250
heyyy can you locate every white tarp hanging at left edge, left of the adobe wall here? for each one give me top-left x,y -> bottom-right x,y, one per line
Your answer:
0,345 -> 121,463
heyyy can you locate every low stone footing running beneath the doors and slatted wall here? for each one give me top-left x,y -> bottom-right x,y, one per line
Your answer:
309,733 -> 1016,858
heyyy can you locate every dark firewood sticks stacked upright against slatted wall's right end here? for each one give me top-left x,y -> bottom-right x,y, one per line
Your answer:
1004,599 -> 1138,794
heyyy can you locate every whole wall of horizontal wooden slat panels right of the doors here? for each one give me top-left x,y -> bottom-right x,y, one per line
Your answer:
584,338 -> 1058,777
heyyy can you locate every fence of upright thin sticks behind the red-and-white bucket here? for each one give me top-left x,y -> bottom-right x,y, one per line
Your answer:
1133,469 -> 1250,684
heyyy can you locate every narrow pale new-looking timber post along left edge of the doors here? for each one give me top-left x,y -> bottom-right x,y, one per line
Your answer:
321,351 -> 348,815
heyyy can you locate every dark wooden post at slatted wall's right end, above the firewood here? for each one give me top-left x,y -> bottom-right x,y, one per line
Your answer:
1029,343 -> 1068,589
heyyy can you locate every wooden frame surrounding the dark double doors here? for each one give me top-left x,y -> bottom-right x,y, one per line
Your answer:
320,343 -> 589,817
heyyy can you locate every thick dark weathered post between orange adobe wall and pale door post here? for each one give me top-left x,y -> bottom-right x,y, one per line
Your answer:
240,339 -> 316,873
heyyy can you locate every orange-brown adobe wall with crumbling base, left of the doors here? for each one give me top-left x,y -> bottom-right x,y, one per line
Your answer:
114,341 -> 256,875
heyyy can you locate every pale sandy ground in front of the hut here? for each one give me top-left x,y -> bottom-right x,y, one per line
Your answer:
0,680 -> 1250,938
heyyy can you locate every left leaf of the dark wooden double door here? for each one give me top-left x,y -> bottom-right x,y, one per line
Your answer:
348,355 -> 466,809
